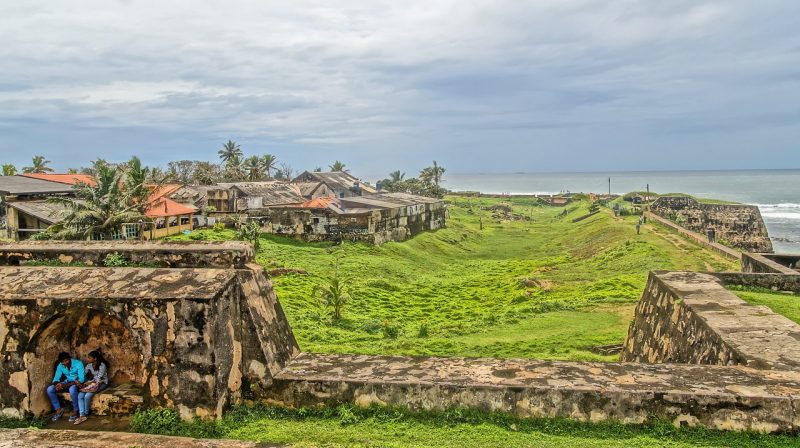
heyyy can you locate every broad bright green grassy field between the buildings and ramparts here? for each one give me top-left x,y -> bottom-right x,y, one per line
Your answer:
176,198 -> 735,361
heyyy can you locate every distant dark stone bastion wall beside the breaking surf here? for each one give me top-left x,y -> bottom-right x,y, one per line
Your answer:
650,196 -> 772,252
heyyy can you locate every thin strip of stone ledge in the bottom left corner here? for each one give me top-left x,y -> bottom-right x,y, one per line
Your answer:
0,429 -> 279,448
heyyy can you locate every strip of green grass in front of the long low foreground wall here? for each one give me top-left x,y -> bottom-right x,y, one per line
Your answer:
125,406 -> 800,448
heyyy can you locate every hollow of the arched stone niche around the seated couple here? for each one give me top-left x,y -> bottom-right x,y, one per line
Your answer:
25,307 -> 144,415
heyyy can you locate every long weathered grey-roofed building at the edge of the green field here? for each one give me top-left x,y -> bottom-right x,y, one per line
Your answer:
249,193 -> 447,244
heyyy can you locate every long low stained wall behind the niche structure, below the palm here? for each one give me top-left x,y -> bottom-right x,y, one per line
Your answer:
0,241 -> 254,268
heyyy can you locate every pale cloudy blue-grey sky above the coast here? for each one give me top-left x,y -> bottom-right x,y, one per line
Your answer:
0,0 -> 800,176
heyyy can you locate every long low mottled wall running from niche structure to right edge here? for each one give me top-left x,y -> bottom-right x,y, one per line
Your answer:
268,353 -> 800,432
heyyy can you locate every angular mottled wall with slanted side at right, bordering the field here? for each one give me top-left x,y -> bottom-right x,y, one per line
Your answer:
621,272 -> 800,370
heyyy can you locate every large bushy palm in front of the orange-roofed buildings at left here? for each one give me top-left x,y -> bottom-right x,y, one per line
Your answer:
49,164 -> 147,240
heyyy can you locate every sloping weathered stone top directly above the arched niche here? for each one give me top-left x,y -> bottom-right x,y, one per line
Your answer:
0,266 -> 236,301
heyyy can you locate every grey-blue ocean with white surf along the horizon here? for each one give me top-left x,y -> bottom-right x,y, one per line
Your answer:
443,170 -> 800,254
